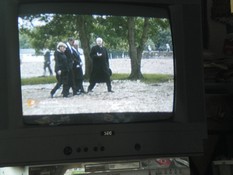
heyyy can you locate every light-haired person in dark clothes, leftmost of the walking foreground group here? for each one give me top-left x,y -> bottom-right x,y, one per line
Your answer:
50,42 -> 69,98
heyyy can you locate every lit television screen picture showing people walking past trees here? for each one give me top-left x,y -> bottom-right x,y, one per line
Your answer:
18,13 -> 175,120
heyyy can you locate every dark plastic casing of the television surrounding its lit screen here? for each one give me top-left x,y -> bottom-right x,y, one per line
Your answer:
0,0 -> 206,166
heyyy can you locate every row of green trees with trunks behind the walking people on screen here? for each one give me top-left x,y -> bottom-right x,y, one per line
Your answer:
19,14 -> 171,79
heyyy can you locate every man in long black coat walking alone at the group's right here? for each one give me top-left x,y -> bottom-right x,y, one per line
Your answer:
88,38 -> 113,92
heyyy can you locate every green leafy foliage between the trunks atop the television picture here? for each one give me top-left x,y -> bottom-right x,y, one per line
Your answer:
19,14 -> 171,51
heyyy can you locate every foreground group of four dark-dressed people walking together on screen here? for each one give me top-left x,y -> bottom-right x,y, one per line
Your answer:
50,38 -> 113,97
